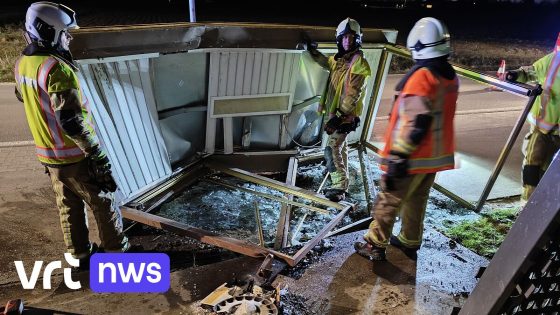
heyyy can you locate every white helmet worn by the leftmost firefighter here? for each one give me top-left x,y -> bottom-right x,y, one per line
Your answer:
25,1 -> 79,47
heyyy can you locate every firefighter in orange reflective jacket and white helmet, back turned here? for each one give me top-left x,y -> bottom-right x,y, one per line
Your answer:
354,17 -> 459,260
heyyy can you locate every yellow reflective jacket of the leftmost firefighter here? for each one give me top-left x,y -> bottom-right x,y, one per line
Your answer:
14,52 -> 94,165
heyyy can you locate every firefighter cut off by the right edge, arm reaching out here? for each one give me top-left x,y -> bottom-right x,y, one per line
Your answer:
506,35 -> 560,205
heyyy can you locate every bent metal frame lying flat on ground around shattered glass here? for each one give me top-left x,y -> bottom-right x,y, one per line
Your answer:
120,152 -> 354,266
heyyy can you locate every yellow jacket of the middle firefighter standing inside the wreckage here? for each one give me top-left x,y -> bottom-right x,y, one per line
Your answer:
319,50 -> 371,116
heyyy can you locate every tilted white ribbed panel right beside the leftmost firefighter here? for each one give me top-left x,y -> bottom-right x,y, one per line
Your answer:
80,56 -> 171,198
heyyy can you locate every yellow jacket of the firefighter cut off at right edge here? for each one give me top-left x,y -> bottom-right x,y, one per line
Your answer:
518,52 -> 560,134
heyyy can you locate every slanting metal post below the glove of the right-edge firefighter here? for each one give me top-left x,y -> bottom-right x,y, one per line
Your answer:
474,85 -> 542,212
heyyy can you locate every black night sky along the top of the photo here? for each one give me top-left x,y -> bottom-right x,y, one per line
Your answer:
0,0 -> 560,46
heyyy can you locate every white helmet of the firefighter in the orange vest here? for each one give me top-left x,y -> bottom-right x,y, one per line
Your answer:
406,17 -> 451,59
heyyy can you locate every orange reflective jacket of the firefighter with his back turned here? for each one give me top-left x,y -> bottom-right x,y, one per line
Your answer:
381,68 -> 459,174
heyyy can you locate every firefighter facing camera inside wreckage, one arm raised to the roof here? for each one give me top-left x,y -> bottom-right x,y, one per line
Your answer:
308,18 -> 371,202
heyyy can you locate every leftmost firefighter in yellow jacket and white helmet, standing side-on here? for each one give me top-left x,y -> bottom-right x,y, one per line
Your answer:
14,1 -> 130,267
